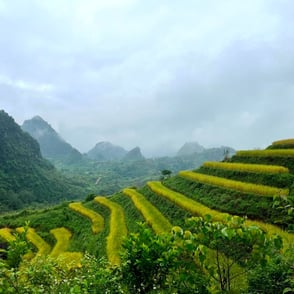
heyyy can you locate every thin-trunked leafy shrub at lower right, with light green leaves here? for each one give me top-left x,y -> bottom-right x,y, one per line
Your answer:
188,215 -> 282,291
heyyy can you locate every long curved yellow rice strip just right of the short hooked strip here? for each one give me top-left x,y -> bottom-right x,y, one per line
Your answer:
94,196 -> 128,265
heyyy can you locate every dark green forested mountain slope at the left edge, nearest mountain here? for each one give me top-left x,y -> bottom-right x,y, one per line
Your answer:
0,110 -> 81,211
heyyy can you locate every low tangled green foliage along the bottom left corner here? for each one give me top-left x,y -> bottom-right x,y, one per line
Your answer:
0,255 -> 125,294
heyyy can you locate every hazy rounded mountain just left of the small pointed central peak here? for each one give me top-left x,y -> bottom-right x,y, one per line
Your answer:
87,142 -> 127,161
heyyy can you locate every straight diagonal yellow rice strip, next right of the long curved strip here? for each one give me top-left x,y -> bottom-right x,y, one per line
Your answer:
123,189 -> 172,234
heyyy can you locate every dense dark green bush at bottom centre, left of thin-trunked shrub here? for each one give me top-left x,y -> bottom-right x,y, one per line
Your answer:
121,225 -> 208,293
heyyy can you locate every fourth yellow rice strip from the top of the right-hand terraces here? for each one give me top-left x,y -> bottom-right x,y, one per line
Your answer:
179,171 -> 289,197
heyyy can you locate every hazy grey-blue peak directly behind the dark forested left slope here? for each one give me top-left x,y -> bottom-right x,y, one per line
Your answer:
22,116 -> 82,164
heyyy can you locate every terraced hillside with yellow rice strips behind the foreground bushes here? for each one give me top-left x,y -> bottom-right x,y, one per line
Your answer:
0,140 -> 294,292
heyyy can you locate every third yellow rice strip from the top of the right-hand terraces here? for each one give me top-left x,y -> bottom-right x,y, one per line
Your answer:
203,161 -> 289,174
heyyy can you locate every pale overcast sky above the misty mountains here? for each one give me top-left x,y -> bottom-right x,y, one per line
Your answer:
0,0 -> 294,156
